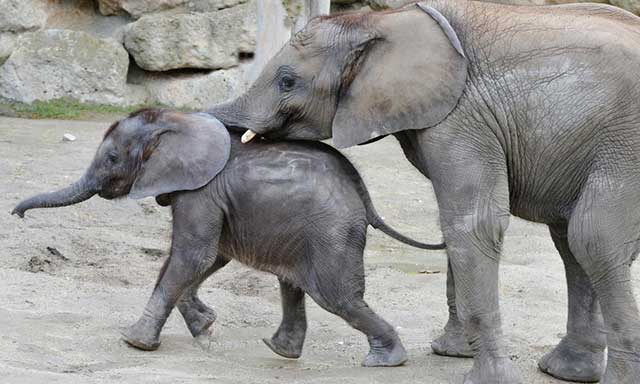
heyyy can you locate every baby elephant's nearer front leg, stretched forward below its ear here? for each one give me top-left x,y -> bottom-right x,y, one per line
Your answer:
123,198 -> 224,350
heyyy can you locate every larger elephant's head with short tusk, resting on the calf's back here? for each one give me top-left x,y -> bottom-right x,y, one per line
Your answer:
211,5 -> 467,148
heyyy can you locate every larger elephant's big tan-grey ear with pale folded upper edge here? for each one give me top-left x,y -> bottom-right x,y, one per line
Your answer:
332,4 -> 467,148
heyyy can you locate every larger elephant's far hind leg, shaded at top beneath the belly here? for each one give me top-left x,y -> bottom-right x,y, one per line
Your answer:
538,224 -> 606,383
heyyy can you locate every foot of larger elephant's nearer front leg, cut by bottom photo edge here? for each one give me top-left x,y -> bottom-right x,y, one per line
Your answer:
464,357 -> 522,384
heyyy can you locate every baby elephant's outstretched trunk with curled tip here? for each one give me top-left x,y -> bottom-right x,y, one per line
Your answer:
11,175 -> 97,217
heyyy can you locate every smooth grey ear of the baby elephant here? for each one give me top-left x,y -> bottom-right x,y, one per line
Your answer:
129,112 -> 231,199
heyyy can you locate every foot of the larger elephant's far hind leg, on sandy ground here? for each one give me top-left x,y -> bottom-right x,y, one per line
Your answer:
538,336 -> 604,383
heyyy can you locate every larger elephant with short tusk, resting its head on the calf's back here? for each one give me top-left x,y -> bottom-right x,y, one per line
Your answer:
211,0 -> 640,384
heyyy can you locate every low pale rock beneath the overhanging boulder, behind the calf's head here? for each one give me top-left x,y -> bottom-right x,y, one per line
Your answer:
141,68 -> 244,109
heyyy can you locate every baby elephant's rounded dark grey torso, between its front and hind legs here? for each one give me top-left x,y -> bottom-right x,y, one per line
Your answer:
221,137 -> 367,273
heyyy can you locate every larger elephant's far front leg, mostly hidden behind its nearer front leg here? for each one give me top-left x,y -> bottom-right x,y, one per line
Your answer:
431,263 -> 473,357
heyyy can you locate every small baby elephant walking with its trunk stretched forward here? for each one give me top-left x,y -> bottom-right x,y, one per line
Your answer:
13,109 -> 444,366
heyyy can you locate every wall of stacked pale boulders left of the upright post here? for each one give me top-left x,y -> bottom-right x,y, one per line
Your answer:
0,0 -> 257,108
